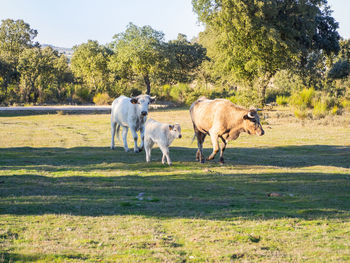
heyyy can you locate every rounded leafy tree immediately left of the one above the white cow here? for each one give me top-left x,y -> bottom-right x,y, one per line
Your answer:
71,40 -> 111,93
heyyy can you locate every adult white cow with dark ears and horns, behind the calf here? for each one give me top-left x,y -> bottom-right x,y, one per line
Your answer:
111,95 -> 155,152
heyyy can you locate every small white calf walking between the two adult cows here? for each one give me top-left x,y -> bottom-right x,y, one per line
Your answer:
145,119 -> 182,165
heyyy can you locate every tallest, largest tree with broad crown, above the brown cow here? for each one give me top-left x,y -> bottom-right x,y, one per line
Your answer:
192,0 -> 339,103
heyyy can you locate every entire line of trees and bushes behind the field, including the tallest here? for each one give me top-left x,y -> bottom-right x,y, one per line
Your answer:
0,0 -> 350,116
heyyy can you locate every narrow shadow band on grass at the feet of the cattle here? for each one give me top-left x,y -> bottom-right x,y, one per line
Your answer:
0,145 -> 350,170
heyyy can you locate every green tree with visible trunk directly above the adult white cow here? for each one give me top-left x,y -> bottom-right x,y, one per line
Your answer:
109,23 -> 164,94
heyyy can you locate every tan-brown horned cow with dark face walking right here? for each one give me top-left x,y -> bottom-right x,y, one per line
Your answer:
190,97 -> 265,163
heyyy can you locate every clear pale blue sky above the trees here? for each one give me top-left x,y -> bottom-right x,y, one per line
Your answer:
0,0 -> 350,47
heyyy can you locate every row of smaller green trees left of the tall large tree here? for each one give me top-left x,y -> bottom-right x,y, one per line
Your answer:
0,19 -> 208,105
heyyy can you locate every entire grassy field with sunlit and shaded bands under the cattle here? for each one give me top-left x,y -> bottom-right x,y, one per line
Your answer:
0,110 -> 350,262
